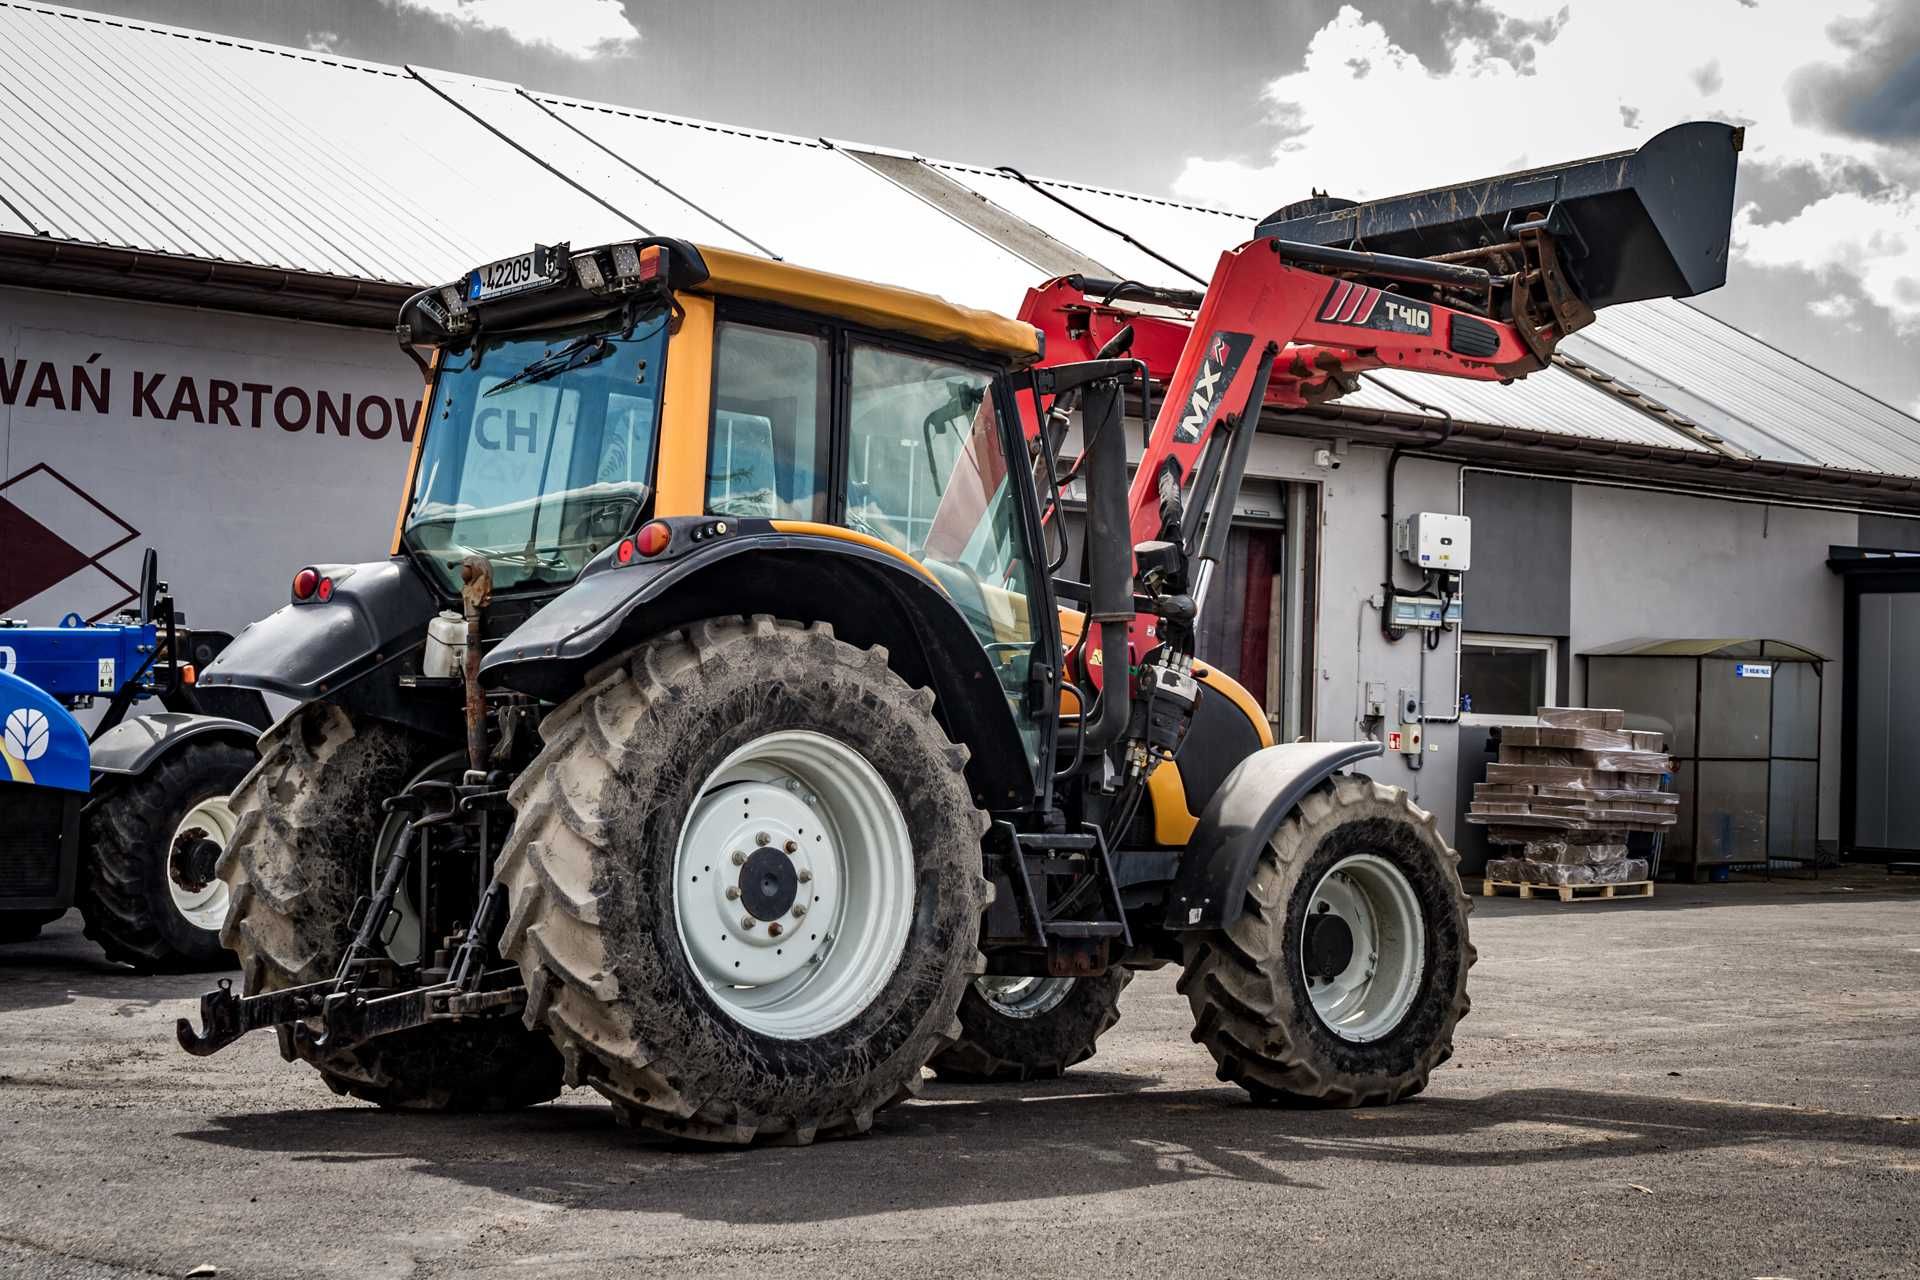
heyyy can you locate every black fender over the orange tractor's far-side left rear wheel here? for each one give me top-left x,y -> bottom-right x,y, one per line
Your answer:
198,557 -> 451,735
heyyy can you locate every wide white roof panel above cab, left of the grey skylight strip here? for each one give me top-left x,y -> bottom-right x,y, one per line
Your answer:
536,94 -> 1035,313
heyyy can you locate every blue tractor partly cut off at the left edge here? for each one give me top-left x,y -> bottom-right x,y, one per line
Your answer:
0,551 -> 267,973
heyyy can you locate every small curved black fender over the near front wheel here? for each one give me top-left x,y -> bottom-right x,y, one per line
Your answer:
1165,743 -> 1382,933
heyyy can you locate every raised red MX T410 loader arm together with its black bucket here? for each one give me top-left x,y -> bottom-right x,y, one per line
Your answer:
1020,121 -> 1743,543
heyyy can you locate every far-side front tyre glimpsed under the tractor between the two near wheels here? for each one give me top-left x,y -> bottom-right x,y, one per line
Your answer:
929,969 -> 1133,1084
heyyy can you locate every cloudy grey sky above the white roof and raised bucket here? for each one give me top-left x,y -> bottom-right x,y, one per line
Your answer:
73,0 -> 1920,413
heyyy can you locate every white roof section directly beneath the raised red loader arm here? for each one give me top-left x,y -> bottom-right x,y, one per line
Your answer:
1334,368 -> 1707,453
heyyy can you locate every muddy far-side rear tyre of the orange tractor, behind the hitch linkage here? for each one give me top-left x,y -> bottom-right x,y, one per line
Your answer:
219,702 -> 561,1111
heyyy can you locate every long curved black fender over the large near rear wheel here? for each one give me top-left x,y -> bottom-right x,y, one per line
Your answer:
480,516 -> 1035,810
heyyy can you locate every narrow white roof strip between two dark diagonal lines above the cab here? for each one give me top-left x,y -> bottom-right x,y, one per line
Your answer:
409,67 -> 760,253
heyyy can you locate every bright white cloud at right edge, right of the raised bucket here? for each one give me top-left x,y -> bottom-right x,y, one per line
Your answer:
1734,190 -> 1920,332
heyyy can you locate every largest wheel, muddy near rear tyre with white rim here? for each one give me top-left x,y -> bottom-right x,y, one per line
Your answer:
501,616 -> 991,1144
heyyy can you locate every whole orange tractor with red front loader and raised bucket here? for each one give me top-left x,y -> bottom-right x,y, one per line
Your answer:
179,125 -> 1738,1142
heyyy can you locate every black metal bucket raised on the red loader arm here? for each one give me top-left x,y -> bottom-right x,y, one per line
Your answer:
1258,121 -> 1743,309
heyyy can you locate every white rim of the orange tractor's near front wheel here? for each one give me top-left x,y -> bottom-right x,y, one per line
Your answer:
1300,854 -> 1427,1044
